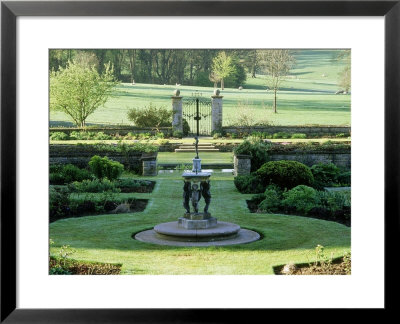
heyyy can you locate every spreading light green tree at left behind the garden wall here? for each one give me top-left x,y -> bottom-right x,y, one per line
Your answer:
50,61 -> 117,127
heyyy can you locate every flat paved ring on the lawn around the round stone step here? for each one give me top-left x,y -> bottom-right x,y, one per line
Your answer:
135,222 -> 260,246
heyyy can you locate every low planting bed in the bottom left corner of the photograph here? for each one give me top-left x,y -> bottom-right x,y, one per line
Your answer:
49,257 -> 122,275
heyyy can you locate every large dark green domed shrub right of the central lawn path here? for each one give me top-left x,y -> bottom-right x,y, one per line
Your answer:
255,161 -> 314,189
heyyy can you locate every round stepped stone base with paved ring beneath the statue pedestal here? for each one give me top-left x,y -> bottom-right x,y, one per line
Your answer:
135,222 -> 260,246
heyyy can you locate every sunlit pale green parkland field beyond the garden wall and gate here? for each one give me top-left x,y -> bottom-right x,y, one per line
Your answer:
50,50 -> 351,125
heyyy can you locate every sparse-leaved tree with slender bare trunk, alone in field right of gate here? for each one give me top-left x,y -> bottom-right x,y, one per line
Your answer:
260,50 -> 295,113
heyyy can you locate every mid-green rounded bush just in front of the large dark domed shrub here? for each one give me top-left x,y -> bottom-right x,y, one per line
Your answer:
282,185 -> 319,215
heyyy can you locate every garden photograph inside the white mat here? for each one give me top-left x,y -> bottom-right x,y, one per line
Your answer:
48,47 -> 352,276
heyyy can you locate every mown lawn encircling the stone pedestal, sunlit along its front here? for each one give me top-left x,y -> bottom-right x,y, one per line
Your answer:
50,172 -> 350,275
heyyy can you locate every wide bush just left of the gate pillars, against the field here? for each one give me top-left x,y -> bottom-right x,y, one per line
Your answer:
128,103 -> 172,130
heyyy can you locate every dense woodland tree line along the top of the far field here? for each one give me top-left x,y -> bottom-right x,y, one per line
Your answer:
49,49 -> 256,87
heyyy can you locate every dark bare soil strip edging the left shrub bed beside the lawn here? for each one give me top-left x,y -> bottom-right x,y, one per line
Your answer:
50,198 -> 149,223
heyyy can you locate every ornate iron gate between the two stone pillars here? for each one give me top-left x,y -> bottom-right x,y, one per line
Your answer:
182,93 -> 211,136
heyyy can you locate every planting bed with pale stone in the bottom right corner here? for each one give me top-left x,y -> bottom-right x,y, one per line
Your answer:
274,258 -> 351,275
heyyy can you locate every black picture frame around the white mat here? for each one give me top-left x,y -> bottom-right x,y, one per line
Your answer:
1,0 -> 400,323
